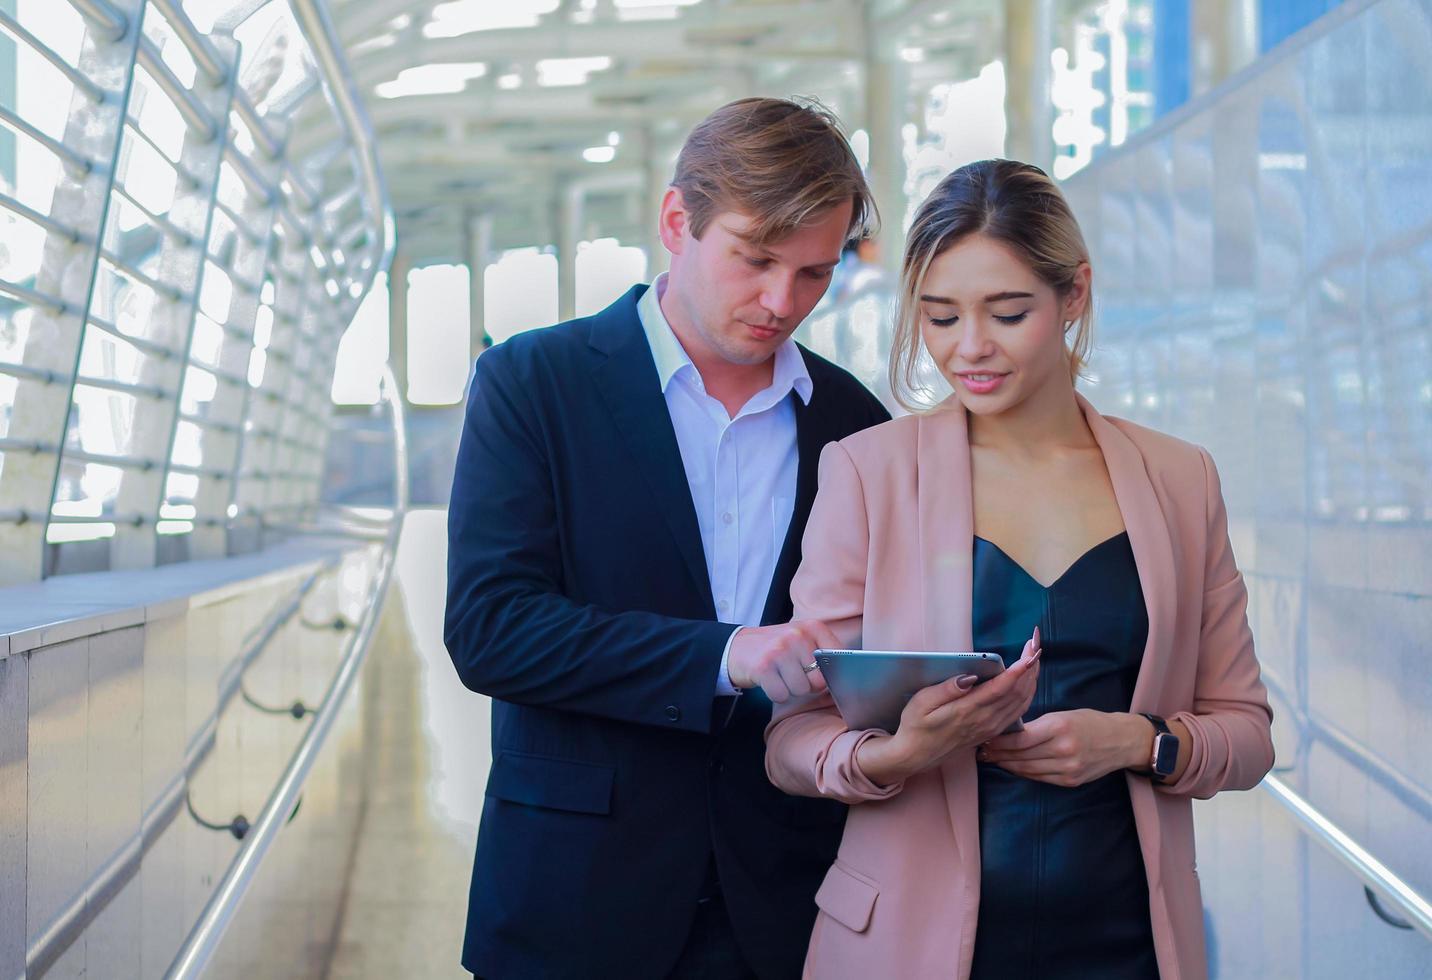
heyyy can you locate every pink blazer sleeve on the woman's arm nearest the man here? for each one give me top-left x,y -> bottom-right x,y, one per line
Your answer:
766,443 -> 902,804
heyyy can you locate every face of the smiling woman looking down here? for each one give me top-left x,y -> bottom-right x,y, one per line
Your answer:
919,235 -> 1090,415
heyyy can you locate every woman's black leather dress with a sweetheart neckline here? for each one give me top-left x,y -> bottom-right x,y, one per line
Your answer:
972,533 -> 1158,980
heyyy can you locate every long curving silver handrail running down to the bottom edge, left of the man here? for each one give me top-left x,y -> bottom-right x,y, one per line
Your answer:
165,367 -> 408,980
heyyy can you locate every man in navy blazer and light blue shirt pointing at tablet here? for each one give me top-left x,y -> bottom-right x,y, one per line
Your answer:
444,99 -> 888,980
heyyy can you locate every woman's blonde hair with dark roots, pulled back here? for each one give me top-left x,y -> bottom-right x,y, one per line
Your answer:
889,160 -> 1094,411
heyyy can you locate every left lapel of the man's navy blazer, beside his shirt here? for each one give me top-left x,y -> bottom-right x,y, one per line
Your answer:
590,287 -> 716,619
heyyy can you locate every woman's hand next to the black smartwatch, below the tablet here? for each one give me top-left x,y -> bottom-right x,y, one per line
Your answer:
975,708 -> 1153,787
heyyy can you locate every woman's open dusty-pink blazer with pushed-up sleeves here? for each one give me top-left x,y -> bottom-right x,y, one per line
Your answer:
766,397 -> 1273,980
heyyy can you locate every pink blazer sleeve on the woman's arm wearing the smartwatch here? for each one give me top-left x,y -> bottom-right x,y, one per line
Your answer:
1156,448 -> 1273,799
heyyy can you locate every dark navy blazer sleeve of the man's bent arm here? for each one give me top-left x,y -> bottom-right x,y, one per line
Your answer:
442,347 -> 735,732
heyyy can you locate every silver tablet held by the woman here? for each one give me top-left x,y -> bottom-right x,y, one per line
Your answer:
815,649 -> 1022,732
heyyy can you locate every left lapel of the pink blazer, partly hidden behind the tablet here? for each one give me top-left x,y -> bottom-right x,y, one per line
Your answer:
915,397 -> 979,876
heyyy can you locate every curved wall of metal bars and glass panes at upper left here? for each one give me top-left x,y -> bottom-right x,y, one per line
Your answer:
0,0 -> 392,585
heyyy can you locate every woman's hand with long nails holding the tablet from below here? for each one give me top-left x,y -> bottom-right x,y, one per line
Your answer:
856,626 -> 1040,787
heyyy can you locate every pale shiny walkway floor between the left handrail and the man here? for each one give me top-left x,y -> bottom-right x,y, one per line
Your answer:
328,510 -> 491,980
